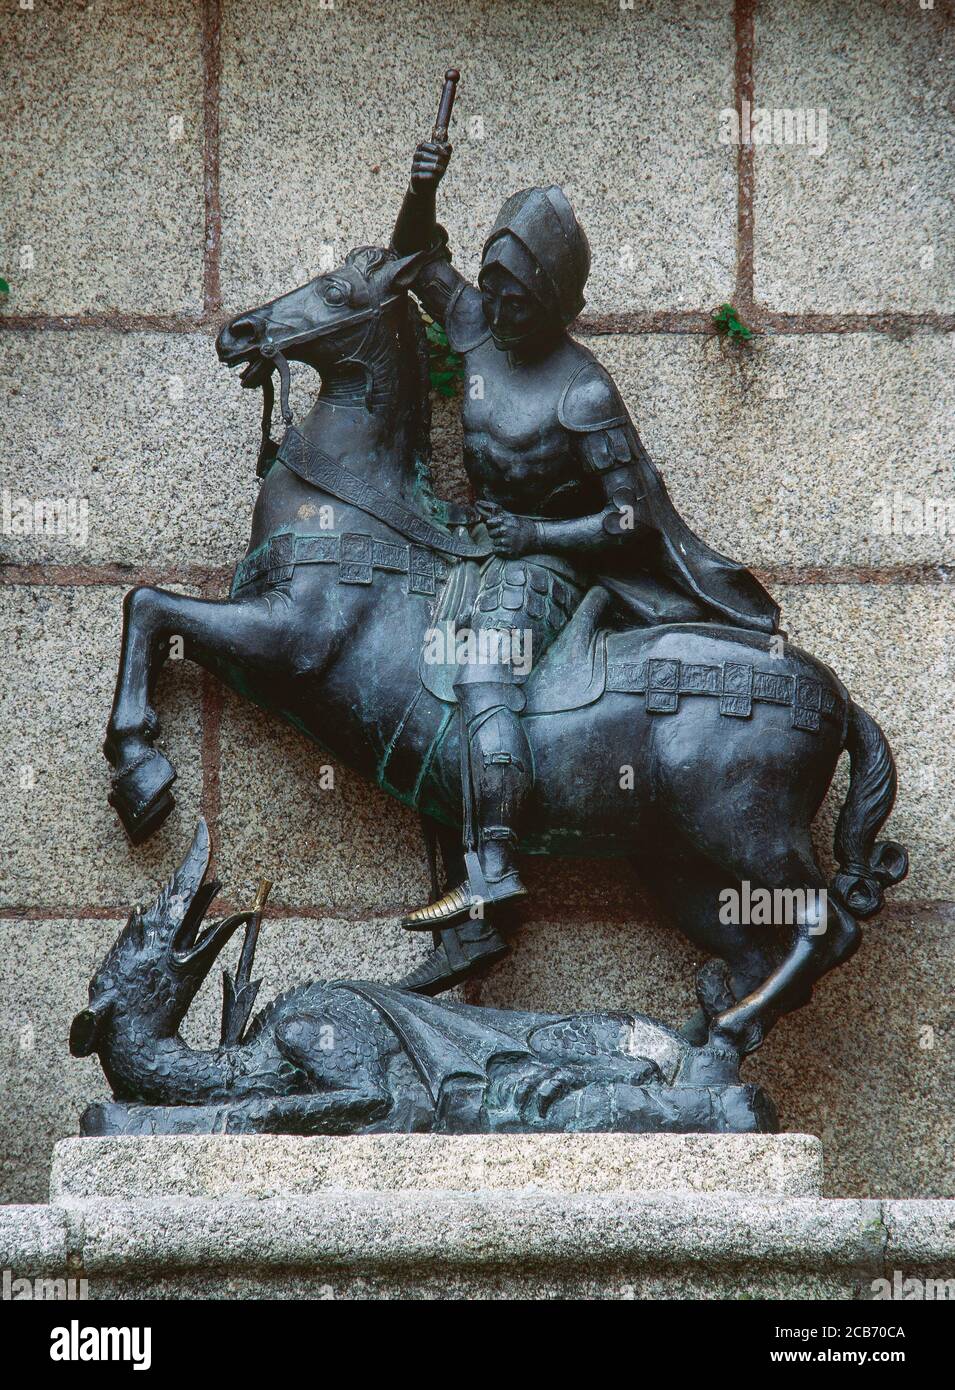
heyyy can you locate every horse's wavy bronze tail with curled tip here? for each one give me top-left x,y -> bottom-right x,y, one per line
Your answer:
829,701 -> 909,917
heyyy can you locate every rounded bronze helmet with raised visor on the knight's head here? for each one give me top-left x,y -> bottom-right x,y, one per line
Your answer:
481,183 -> 591,327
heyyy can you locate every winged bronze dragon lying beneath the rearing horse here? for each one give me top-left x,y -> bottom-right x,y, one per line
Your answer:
70,820 -> 776,1134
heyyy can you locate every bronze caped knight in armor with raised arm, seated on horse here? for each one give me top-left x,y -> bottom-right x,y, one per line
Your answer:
392,139 -> 778,930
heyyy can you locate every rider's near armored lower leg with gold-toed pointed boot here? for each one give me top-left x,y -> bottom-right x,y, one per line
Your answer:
402,669 -> 532,931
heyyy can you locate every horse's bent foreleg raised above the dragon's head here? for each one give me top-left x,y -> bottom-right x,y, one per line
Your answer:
103,587 -> 298,844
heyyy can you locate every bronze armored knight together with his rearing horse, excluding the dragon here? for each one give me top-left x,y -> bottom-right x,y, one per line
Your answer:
98,67 -> 908,1073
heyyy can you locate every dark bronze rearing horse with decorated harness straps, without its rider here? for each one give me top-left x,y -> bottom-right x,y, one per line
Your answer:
104,247 -> 908,1055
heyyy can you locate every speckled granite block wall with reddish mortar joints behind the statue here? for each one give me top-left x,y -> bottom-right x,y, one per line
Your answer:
0,0 -> 955,1202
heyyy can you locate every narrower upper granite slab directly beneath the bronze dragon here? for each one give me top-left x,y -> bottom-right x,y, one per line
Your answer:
51,1128 -> 822,1202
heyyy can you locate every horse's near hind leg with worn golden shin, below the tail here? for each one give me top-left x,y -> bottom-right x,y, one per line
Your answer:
710,833 -> 862,1052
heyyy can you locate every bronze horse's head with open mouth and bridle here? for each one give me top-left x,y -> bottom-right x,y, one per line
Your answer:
215,246 -> 421,386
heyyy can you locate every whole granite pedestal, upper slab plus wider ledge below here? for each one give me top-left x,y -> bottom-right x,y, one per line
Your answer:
0,1134 -> 955,1298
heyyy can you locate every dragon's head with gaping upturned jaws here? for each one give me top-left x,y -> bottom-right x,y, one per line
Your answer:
70,820 -> 249,1056
